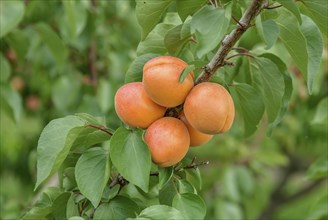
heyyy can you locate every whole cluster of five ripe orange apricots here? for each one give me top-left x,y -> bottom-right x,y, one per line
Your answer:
115,56 -> 235,167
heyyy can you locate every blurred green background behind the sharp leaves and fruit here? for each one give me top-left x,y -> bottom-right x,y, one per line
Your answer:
0,0 -> 328,220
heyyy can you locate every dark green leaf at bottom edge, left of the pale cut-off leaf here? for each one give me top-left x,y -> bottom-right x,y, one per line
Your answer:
93,196 -> 140,220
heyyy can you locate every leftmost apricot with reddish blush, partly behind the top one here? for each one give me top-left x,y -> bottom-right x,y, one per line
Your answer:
114,82 -> 166,128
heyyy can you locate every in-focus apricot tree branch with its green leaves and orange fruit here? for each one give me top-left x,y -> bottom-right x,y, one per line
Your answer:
9,0 -> 328,220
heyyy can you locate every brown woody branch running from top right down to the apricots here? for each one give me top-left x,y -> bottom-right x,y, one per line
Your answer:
165,0 -> 268,117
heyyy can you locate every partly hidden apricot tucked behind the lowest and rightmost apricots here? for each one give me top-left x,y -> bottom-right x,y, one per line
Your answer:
179,113 -> 213,146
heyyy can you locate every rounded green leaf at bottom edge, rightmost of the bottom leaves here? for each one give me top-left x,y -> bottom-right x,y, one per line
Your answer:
172,193 -> 206,219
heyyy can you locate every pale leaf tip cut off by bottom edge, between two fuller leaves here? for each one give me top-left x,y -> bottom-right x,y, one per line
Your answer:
137,205 -> 186,220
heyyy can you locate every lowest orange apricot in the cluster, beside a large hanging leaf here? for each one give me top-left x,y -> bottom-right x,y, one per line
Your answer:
145,117 -> 190,167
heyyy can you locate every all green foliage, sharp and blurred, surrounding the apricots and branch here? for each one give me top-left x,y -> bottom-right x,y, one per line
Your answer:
0,0 -> 328,219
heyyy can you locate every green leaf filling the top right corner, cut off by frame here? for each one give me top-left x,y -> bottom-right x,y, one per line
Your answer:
301,0 -> 328,37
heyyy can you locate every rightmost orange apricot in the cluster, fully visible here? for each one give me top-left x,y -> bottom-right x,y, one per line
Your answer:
184,82 -> 235,134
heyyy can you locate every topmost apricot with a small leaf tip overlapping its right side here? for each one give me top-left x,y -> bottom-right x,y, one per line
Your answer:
142,56 -> 194,107
